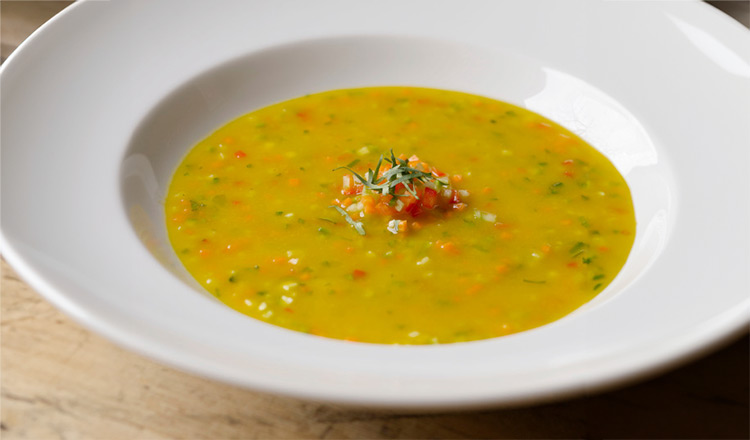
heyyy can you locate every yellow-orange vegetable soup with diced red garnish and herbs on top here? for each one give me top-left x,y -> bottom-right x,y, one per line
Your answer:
165,87 -> 635,344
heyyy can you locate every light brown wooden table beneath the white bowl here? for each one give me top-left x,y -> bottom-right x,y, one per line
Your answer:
0,0 -> 750,439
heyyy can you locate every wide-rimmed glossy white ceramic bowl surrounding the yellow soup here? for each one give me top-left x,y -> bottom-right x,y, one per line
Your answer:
0,0 -> 750,409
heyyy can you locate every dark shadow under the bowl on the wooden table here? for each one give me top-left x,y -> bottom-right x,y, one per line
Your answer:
302,335 -> 750,439
